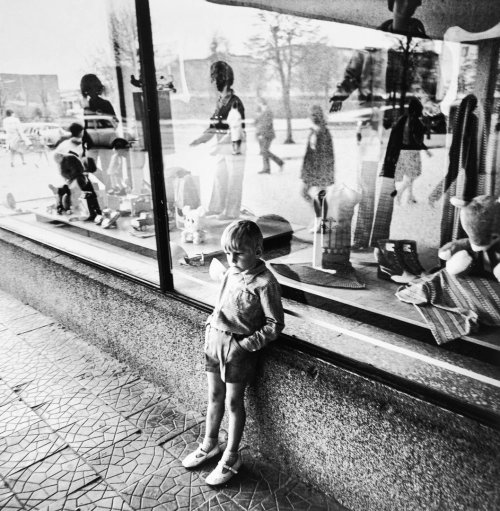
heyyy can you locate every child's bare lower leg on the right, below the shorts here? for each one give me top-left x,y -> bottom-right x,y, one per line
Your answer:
222,383 -> 246,466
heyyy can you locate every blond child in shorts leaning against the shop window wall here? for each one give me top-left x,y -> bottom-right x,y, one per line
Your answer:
182,220 -> 285,486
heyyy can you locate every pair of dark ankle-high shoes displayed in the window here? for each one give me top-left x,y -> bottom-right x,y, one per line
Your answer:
375,240 -> 425,284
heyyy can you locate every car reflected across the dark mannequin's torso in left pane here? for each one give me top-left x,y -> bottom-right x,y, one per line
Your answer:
83,115 -> 136,149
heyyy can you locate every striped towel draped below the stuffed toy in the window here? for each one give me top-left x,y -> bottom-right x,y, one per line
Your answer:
396,269 -> 500,344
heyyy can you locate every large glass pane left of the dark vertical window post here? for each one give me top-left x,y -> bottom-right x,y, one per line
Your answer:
0,0 -> 158,283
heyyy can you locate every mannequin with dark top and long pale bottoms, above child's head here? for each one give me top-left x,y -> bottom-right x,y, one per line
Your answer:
190,60 -> 246,220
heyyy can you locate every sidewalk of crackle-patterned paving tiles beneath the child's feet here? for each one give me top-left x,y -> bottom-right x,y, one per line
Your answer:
0,291 -> 346,511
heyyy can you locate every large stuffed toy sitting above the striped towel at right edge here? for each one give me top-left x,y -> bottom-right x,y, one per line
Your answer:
438,195 -> 500,281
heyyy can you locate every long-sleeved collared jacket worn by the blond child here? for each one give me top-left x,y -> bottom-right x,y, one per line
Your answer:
207,260 -> 285,351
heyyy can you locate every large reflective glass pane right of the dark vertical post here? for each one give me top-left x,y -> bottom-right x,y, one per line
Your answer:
151,0 -> 500,350
